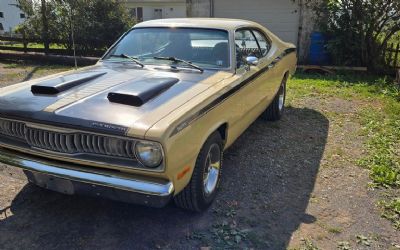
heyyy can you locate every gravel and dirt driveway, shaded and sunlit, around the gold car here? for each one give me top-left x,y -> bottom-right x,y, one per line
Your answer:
0,62 -> 400,249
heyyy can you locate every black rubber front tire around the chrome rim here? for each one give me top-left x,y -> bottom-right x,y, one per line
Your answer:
174,132 -> 223,212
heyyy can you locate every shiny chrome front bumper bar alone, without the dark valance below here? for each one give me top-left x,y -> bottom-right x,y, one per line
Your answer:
0,148 -> 174,197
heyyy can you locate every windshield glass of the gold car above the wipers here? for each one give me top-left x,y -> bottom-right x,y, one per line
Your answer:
103,28 -> 230,68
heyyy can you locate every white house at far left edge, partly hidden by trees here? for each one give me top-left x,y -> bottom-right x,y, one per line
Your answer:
0,0 -> 25,34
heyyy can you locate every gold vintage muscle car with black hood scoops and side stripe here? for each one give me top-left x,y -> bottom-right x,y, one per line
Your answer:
0,18 -> 297,211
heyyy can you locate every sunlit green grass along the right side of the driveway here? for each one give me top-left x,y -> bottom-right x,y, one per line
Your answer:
288,74 -> 400,229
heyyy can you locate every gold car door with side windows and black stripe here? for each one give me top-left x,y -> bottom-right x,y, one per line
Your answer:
225,28 -> 275,143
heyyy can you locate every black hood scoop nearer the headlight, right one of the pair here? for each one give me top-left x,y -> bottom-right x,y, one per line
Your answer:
107,78 -> 179,107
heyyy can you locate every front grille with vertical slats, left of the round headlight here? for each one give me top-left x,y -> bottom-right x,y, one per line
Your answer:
0,119 -> 135,159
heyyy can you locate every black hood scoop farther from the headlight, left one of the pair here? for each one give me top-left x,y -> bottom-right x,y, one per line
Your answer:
31,72 -> 106,95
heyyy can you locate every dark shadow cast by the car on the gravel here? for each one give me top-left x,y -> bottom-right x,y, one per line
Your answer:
0,108 -> 329,249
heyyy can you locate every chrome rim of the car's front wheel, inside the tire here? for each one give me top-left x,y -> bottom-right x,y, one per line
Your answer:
203,143 -> 221,197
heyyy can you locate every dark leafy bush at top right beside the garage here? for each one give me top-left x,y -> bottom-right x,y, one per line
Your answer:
308,0 -> 400,72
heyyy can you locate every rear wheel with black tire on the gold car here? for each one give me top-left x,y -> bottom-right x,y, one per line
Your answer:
263,75 -> 288,121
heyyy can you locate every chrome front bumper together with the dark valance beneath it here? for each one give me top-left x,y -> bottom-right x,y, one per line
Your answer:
0,147 -> 174,207
